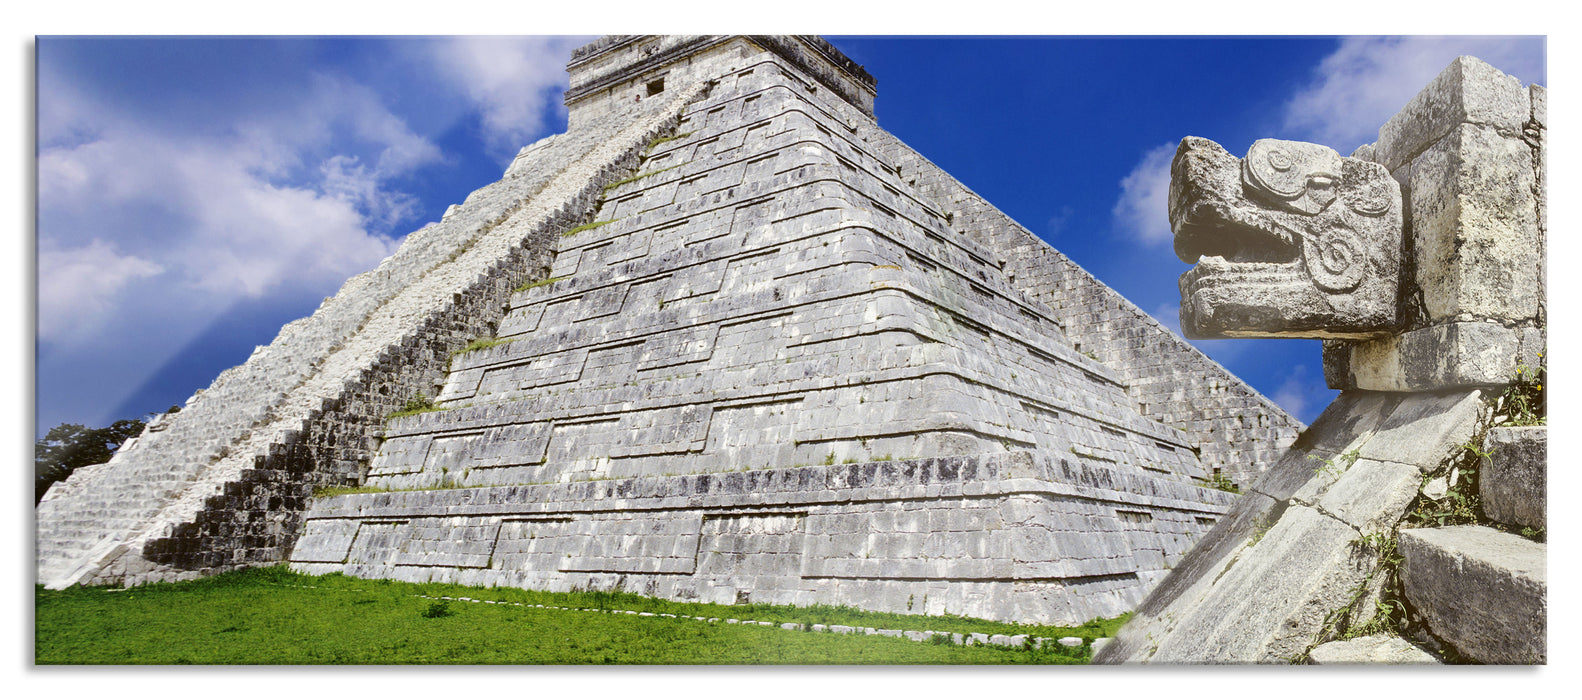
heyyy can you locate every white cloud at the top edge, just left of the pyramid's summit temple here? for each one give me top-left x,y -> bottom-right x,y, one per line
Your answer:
432,36 -> 589,155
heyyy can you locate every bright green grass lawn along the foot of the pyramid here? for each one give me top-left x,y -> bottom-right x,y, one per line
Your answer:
33,567 -> 1122,665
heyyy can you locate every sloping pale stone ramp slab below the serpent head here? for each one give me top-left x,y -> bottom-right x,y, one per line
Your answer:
1095,391 -> 1481,664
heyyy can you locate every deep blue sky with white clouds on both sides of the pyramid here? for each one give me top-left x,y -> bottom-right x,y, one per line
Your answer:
35,35 -> 1547,434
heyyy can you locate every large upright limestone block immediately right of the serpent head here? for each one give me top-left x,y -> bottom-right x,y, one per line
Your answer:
1408,122 -> 1542,321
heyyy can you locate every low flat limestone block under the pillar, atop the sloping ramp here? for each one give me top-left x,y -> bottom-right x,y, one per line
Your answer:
1340,321 -> 1522,391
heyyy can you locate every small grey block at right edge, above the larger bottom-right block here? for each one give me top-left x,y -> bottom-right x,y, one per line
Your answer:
1478,426 -> 1549,527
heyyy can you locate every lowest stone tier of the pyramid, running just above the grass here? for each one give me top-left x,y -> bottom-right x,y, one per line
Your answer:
291,451 -> 1232,624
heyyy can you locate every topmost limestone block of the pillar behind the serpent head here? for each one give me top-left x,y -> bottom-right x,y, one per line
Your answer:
1375,55 -> 1530,171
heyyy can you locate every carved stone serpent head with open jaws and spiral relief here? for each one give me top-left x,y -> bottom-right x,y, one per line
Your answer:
1169,138 -> 1402,339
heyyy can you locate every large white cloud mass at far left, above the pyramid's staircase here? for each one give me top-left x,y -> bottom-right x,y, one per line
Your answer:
38,60 -> 441,354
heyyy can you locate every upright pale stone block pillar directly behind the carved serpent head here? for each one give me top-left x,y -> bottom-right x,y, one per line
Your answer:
1324,57 -> 1547,391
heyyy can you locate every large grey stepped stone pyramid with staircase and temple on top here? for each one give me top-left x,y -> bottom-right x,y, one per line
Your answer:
40,36 -> 1300,622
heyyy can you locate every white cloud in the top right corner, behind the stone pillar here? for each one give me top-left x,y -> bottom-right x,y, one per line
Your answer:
1285,36 -> 1546,154
